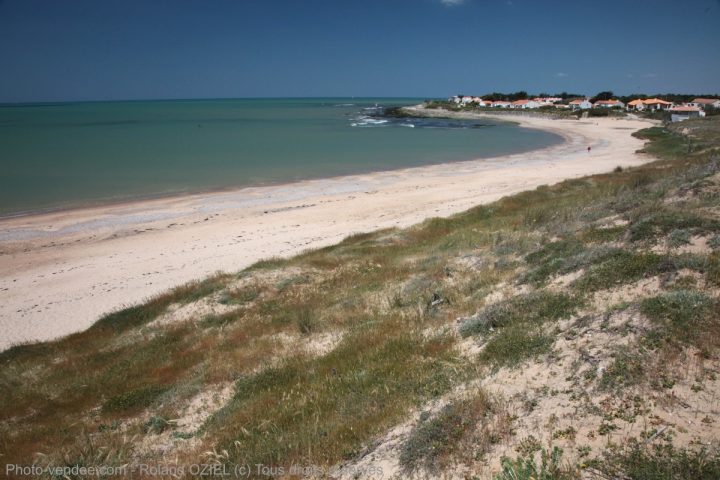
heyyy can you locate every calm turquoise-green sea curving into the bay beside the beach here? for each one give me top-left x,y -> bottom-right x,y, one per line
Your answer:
0,98 -> 561,215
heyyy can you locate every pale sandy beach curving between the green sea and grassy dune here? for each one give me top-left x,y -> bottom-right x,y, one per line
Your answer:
0,112 -> 651,349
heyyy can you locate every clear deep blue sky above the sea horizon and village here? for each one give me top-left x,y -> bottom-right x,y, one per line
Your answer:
0,0 -> 720,103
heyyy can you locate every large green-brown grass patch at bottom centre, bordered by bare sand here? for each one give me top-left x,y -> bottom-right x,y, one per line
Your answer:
205,329 -> 462,465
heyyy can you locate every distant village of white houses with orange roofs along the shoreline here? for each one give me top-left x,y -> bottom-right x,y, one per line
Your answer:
448,95 -> 720,121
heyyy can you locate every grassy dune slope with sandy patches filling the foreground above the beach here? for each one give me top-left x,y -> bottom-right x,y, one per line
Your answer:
0,117 -> 720,478
